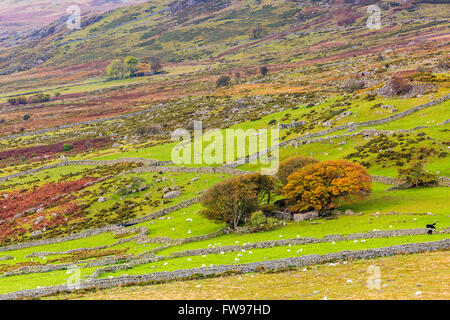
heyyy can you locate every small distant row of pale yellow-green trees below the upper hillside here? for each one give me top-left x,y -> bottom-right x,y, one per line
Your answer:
106,56 -> 163,80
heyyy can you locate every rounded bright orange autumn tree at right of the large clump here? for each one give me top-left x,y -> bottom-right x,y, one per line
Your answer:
282,160 -> 371,212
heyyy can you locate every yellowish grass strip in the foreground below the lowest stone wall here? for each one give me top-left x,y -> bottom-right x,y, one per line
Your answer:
49,252 -> 450,300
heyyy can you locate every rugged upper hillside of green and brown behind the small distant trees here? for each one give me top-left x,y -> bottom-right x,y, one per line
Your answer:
0,0 -> 449,79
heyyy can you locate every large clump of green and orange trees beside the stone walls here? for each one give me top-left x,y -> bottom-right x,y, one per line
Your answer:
201,157 -> 371,229
